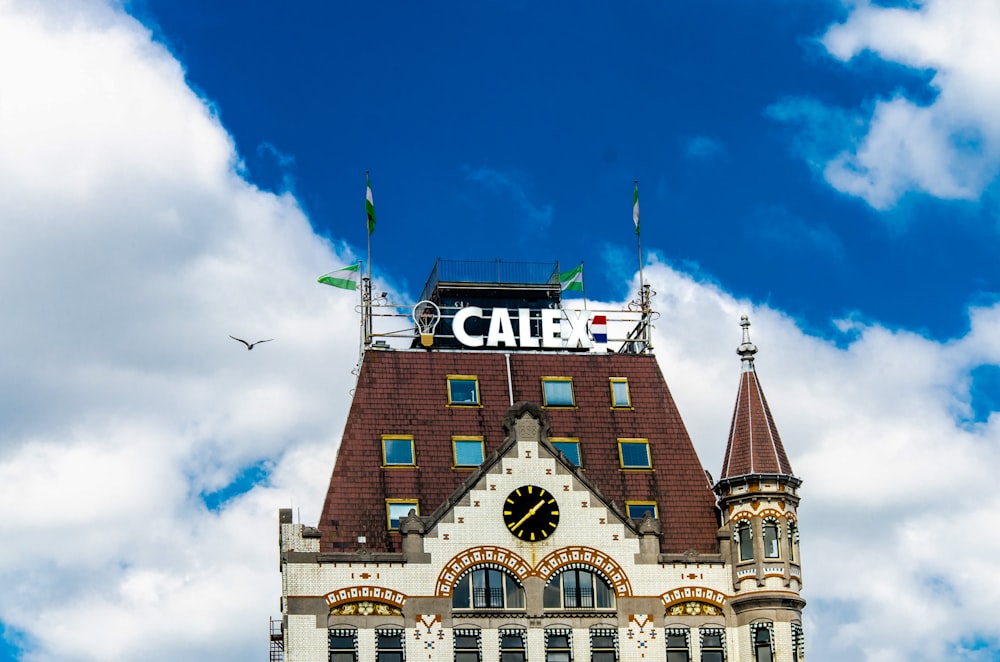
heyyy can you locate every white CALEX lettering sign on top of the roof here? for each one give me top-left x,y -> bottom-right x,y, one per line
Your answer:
452,306 -> 594,349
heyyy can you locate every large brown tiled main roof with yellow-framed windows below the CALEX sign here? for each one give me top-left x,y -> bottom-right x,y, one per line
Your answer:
319,350 -> 718,554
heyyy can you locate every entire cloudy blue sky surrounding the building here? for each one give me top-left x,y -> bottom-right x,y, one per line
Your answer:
0,0 -> 1000,662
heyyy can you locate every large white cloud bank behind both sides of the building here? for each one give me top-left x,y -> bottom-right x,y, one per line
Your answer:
0,1 -> 1000,662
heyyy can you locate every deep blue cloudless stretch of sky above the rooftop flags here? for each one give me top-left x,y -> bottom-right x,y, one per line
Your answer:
135,0 -> 1000,338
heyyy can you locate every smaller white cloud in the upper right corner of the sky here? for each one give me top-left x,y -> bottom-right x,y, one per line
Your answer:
780,0 -> 1000,209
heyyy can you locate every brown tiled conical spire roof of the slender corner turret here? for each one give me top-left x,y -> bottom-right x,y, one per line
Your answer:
719,360 -> 793,480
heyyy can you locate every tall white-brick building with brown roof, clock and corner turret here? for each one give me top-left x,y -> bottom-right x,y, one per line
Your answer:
274,261 -> 805,662
